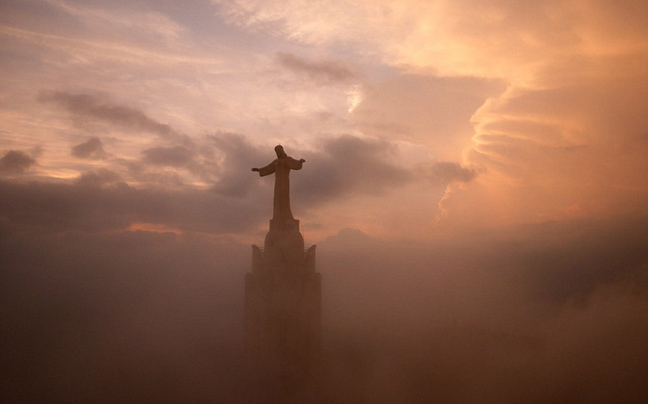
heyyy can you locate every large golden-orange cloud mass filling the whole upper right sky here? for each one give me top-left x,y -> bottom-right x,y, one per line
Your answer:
215,0 -> 648,229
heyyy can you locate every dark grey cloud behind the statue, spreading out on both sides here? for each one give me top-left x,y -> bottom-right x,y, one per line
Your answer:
211,133 -> 414,207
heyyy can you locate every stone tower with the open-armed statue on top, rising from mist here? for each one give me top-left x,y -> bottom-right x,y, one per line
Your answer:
245,146 -> 322,383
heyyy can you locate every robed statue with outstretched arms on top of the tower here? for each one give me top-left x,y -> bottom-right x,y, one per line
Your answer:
252,145 -> 306,219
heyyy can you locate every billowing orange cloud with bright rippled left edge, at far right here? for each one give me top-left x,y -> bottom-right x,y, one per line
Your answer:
444,68 -> 648,226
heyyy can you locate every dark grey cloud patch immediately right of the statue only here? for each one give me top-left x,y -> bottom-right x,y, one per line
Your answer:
288,135 -> 413,206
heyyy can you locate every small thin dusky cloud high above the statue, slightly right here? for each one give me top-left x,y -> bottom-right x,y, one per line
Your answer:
276,52 -> 356,83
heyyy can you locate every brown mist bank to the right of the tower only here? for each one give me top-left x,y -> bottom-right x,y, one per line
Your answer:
318,216 -> 648,403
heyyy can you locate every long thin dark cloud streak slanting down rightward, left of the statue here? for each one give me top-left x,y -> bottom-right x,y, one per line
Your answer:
38,91 -> 187,141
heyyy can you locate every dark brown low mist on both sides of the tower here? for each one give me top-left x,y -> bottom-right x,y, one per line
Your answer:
1,210 -> 648,403
